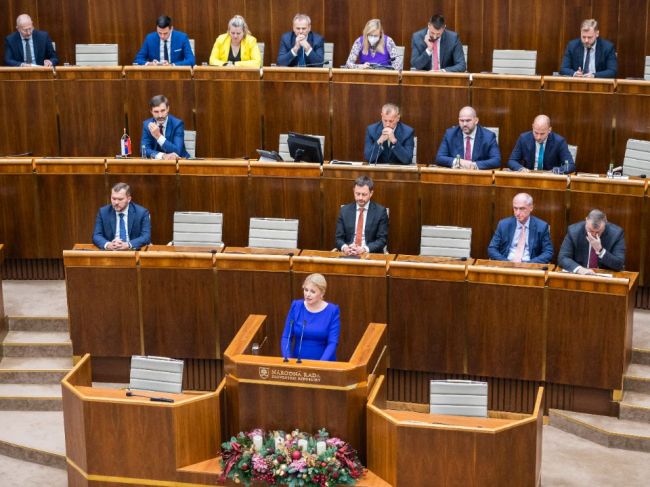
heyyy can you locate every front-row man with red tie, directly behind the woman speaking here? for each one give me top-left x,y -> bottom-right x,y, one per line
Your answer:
336,176 -> 388,255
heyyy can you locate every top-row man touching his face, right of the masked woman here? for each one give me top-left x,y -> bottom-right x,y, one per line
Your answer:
411,14 -> 467,73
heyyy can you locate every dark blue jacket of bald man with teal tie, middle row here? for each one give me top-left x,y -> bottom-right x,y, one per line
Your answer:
508,131 -> 576,173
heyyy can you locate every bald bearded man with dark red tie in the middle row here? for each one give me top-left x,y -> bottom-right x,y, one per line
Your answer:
436,107 -> 501,169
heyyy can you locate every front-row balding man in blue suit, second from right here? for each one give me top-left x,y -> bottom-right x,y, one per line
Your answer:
488,193 -> 553,264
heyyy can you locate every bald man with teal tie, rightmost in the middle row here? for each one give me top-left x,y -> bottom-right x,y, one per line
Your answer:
508,115 -> 576,174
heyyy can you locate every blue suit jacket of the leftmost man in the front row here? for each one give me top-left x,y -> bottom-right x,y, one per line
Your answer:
93,202 -> 151,249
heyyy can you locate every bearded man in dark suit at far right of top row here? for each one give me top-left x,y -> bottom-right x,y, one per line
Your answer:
560,19 -> 618,78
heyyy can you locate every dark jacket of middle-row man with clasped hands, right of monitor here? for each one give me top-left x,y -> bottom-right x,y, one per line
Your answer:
363,122 -> 415,164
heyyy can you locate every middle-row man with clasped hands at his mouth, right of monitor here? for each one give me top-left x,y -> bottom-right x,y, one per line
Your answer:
363,103 -> 415,164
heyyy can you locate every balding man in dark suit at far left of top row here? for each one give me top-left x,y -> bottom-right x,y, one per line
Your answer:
5,14 -> 59,67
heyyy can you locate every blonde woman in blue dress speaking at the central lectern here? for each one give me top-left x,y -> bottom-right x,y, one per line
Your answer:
282,274 -> 341,361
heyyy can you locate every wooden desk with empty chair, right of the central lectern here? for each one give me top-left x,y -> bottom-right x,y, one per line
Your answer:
367,377 -> 544,487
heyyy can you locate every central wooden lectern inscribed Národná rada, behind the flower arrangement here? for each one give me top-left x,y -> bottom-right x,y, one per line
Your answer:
224,315 -> 386,460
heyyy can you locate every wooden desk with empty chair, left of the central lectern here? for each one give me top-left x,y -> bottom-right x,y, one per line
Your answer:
61,354 -> 222,487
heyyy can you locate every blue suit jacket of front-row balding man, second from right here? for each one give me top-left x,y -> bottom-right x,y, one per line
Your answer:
488,215 -> 553,264
